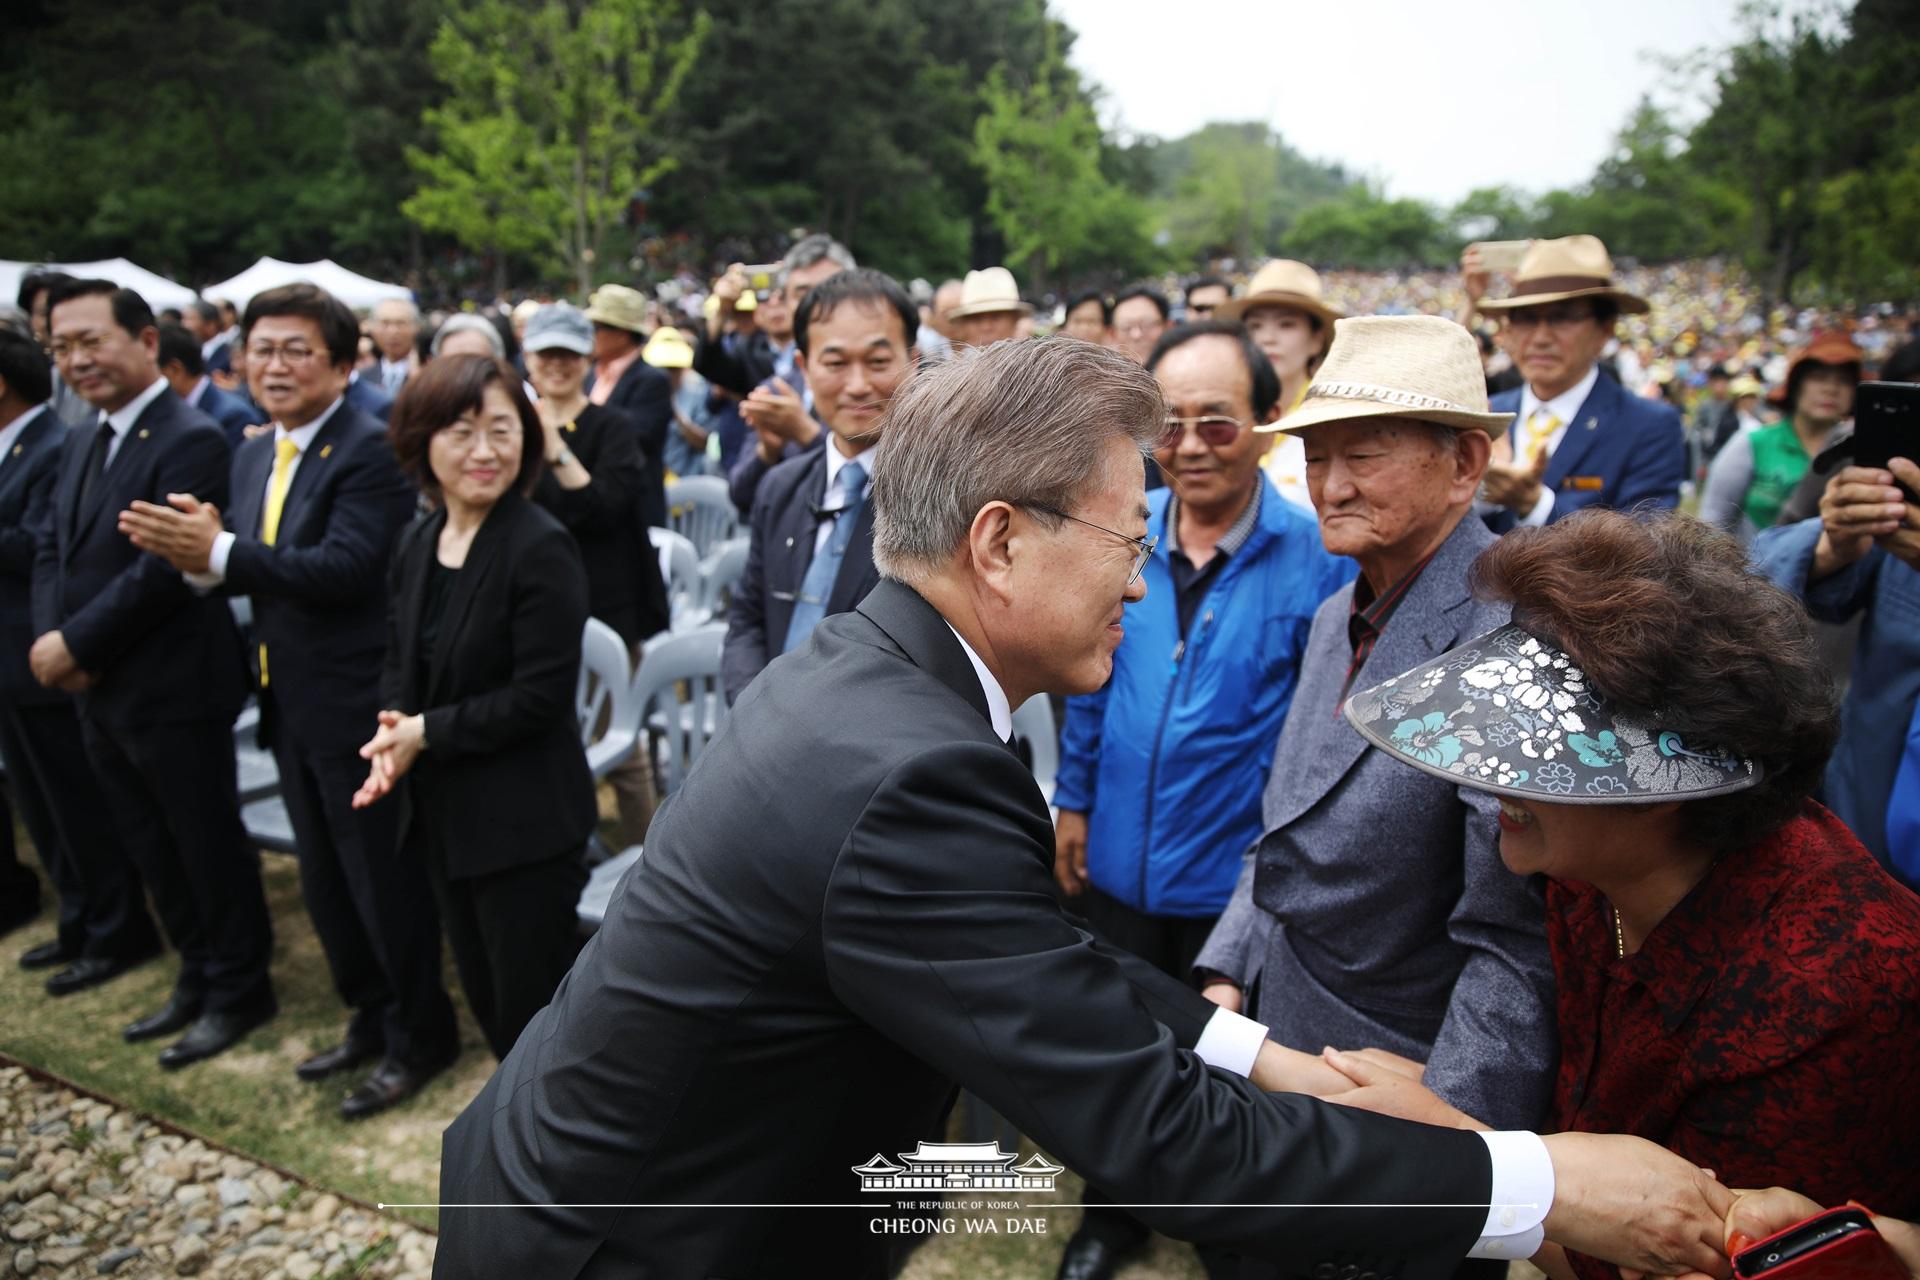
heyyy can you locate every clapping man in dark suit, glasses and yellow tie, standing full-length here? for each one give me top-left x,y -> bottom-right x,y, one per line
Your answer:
119,284 -> 459,1119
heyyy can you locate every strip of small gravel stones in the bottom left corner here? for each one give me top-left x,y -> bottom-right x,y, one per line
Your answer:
0,1067 -> 434,1280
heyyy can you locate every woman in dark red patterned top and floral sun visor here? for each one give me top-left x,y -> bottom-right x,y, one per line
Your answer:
1327,510 -> 1920,1280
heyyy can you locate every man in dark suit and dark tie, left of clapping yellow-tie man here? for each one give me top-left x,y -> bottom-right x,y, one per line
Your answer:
29,280 -> 276,1067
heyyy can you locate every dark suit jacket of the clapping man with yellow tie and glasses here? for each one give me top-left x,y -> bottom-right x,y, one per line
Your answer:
227,405 -> 415,750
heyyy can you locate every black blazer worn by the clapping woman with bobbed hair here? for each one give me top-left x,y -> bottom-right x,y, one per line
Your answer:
380,491 -> 599,879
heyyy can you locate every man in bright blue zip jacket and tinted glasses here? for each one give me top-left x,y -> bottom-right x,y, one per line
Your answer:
1054,320 -> 1354,1278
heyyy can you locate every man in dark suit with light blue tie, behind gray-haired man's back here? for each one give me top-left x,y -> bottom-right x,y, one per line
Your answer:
720,269 -> 920,702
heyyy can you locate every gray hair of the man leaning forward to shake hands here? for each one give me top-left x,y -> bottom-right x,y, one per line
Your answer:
874,338 -> 1167,581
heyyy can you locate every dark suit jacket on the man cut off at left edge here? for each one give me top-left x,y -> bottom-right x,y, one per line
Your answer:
0,405 -> 67,706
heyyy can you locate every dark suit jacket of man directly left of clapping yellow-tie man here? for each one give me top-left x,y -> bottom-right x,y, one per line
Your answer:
33,390 -> 248,725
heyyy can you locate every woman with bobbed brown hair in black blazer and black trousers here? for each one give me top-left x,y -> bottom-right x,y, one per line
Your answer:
353,355 -> 597,1057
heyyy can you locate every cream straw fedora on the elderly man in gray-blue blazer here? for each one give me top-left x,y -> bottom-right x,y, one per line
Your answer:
1254,315 -> 1513,434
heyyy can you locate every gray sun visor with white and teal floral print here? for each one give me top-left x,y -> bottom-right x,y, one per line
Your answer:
1346,624 -> 1761,804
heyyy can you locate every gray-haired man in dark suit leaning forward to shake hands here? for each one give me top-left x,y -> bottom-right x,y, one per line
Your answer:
436,333 -> 1732,1280
